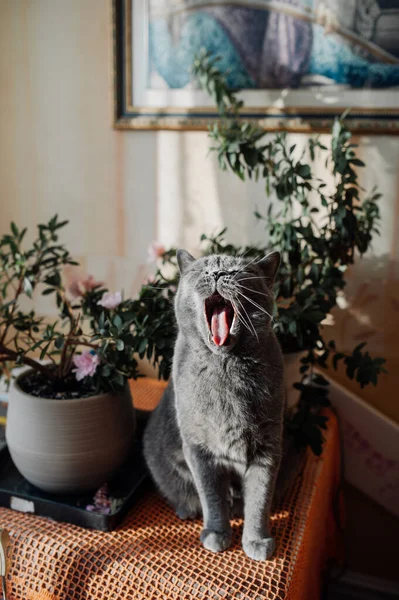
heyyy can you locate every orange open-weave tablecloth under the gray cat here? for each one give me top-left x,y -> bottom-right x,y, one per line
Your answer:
0,380 -> 339,600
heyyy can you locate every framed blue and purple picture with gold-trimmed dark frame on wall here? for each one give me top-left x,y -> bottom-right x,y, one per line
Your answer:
113,0 -> 399,134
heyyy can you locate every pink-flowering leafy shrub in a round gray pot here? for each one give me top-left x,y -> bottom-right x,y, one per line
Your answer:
0,216 -> 141,493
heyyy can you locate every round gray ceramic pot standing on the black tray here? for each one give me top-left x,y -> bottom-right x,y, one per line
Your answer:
6,373 -> 135,493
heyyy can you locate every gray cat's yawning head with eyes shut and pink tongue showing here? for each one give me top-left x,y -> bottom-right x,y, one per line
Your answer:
176,250 -> 280,353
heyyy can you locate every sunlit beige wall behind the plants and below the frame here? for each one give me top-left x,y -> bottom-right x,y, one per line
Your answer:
0,0 -> 399,421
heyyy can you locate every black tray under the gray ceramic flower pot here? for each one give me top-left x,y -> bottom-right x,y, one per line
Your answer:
0,410 -> 150,531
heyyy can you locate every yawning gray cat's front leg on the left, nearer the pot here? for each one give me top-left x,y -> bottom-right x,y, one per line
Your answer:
183,443 -> 231,552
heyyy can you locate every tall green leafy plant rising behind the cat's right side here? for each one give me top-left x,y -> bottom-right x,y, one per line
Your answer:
137,52 -> 386,454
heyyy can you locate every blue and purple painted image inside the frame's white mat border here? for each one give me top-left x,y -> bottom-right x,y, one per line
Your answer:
147,0 -> 399,89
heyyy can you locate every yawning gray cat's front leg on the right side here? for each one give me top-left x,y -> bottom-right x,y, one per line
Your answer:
242,461 -> 278,560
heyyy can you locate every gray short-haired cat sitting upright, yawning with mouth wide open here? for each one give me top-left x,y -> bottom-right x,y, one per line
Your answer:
144,250 -> 284,560
